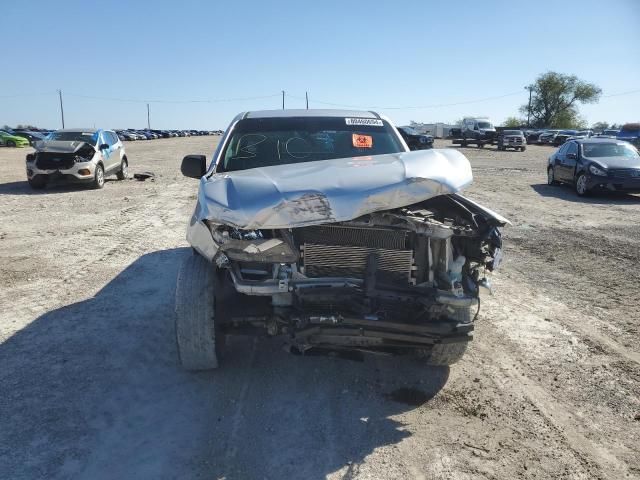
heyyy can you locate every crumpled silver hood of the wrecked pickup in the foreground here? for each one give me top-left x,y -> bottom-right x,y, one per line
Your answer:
196,149 -> 473,229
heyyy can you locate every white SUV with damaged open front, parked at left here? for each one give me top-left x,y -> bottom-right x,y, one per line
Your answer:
26,129 -> 129,189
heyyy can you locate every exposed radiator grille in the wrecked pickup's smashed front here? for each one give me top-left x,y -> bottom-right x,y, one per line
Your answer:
295,225 -> 414,285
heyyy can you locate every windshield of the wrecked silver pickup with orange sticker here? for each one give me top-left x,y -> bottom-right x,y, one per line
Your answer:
216,117 -> 404,172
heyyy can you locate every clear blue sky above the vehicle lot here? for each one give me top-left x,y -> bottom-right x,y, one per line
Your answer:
0,0 -> 640,129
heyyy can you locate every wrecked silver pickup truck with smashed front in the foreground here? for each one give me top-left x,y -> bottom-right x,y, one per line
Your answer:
176,110 -> 507,370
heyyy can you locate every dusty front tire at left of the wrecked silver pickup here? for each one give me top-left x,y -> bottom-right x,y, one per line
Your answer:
176,253 -> 218,371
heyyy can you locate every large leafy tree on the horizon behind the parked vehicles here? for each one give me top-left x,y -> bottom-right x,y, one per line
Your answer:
520,72 -> 602,128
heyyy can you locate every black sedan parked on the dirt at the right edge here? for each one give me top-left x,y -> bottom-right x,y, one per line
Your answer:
547,138 -> 640,196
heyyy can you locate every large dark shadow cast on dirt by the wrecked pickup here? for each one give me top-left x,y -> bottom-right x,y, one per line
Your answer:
0,249 -> 449,480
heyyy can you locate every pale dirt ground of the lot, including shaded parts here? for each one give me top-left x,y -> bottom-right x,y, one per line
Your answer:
0,137 -> 640,480
